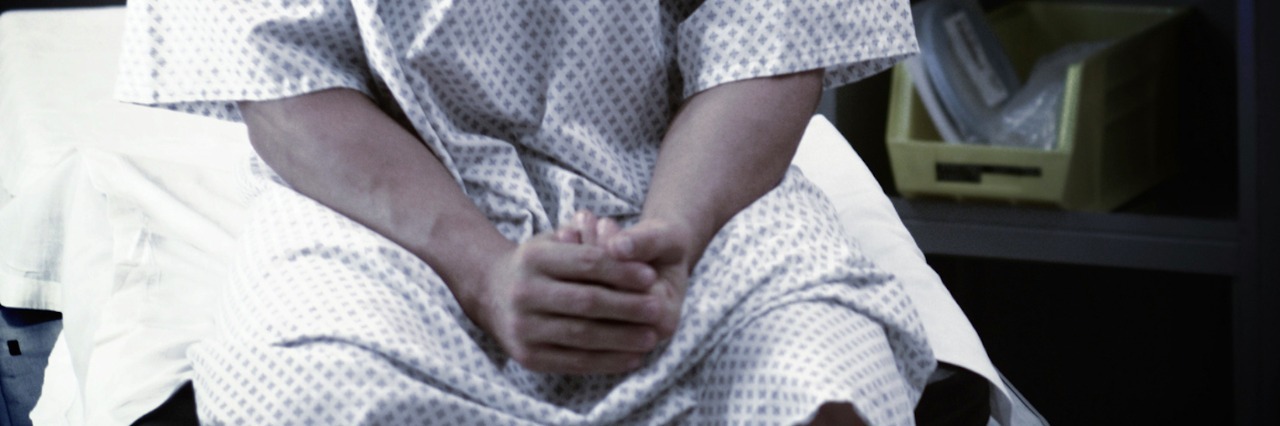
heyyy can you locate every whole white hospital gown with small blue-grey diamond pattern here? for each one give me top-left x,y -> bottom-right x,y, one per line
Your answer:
116,0 -> 934,425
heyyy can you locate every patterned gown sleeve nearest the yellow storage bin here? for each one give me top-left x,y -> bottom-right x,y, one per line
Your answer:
677,0 -> 919,97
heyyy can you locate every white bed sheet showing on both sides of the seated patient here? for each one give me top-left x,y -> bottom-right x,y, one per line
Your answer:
0,8 -> 1010,425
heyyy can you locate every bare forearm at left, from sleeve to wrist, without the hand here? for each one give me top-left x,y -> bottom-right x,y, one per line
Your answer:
241,90 -> 515,308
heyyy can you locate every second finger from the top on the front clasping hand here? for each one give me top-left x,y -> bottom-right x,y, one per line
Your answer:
516,277 -> 663,319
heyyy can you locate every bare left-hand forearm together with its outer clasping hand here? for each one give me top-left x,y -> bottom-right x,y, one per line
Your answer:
241,90 -> 675,374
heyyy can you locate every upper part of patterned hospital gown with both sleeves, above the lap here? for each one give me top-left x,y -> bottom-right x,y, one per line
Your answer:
118,0 -> 916,238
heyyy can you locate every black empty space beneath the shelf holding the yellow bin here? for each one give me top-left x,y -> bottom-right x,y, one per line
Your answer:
928,256 -> 1234,425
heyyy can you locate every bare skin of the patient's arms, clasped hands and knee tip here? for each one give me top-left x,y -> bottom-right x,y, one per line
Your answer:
239,70 -> 858,423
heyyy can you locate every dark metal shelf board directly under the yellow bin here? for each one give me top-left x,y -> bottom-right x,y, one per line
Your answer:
893,197 -> 1239,275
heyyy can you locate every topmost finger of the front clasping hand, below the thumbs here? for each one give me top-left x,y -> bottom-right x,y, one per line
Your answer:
524,243 -> 658,292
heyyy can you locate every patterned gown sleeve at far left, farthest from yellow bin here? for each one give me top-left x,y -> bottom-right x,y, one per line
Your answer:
115,0 -> 370,120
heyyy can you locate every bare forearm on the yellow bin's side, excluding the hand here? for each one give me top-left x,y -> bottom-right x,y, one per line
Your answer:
643,70 -> 823,265
